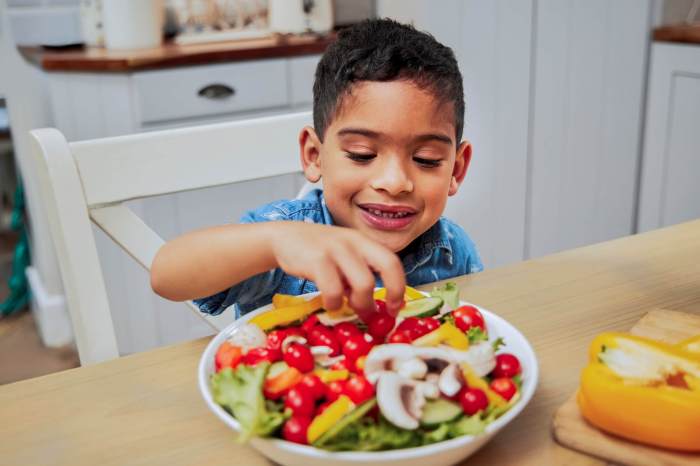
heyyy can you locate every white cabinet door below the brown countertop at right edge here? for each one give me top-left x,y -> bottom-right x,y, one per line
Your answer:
638,43 -> 700,231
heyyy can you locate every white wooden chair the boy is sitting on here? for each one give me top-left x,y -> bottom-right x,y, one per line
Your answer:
31,112 -> 311,365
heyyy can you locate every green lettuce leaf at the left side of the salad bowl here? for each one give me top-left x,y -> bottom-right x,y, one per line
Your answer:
211,363 -> 287,443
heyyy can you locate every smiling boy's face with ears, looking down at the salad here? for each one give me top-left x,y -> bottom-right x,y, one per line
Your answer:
299,81 -> 471,252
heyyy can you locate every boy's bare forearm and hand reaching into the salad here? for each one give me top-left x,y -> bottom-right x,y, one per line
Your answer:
151,221 -> 405,317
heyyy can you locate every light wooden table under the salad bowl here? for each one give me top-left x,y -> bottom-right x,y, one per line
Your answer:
0,220 -> 700,466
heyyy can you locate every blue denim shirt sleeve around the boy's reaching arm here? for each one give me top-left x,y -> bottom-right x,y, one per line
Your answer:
193,206 -> 286,318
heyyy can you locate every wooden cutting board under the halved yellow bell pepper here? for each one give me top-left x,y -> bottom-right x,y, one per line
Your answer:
553,309 -> 700,466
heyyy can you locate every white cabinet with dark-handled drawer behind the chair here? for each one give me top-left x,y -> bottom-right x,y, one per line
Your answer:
44,55 -> 320,353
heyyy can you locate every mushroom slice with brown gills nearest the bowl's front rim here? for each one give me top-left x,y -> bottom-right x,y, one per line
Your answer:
377,372 -> 425,430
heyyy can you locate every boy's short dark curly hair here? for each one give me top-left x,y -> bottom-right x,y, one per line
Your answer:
314,19 -> 464,144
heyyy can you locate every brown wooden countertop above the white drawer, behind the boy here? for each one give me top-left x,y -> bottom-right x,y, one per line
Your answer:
19,34 -> 335,72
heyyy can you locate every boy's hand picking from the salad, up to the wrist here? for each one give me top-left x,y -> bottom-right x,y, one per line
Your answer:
272,222 -> 406,321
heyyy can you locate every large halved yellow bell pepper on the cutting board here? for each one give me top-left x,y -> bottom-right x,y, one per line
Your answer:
577,332 -> 700,452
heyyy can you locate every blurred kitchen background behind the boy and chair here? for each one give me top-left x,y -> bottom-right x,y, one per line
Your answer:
0,0 -> 700,383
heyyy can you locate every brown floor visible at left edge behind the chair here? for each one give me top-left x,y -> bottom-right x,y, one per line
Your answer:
0,233 -> 78,384
